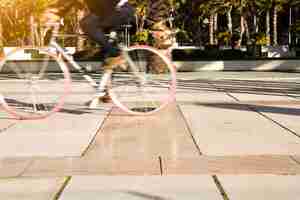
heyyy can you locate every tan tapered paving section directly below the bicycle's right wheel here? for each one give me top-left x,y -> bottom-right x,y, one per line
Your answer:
86,104 -> 199,160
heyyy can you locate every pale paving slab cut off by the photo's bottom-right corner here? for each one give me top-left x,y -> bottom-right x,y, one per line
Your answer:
218,175 -> 300,200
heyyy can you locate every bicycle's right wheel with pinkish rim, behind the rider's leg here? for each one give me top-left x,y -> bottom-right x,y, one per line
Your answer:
109,46 -> 176,115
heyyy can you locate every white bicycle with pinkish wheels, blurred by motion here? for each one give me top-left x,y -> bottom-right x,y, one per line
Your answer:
0,24 -> 176,120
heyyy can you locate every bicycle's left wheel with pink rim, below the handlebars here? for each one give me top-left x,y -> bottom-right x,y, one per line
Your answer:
0,47 -> 71,119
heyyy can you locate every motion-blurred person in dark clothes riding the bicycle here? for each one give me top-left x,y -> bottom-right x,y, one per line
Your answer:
43,0 -> 135,102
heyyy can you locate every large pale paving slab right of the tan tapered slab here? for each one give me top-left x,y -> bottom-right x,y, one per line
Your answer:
180,104 -> 300,156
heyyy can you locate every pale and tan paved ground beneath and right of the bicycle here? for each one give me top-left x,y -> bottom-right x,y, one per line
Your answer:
0,72 -> 300,200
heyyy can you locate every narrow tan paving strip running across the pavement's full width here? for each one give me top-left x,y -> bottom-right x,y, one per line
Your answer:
0,155 -> 300,178
